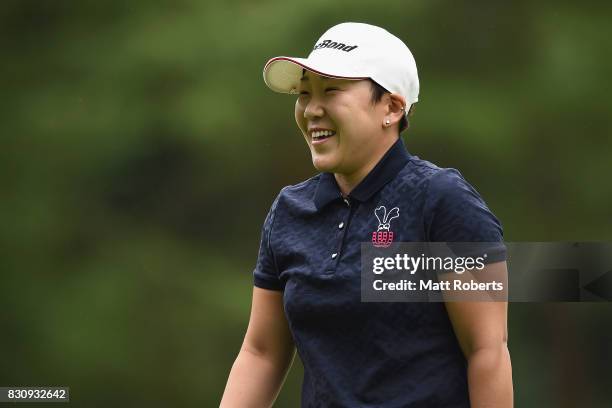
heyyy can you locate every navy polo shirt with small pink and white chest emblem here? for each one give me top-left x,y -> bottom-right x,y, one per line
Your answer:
253,139 -> 503,408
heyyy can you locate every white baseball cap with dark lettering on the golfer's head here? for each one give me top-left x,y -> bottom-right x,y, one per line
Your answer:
263,23 -> 419,105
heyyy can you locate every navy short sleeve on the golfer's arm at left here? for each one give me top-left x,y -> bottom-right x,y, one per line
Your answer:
253,194 -> 284,291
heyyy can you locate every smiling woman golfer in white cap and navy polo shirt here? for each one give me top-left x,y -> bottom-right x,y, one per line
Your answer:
221,23 -> 513,408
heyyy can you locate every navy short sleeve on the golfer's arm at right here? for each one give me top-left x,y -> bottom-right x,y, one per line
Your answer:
424,169 -> 506,263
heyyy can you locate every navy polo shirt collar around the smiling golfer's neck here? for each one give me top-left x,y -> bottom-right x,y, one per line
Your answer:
314,138 -> 411,209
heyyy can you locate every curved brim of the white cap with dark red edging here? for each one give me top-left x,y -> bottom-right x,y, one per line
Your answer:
263,57 -> 368,94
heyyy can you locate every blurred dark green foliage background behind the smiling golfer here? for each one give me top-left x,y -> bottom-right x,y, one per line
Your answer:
0,0 -> 612,407
